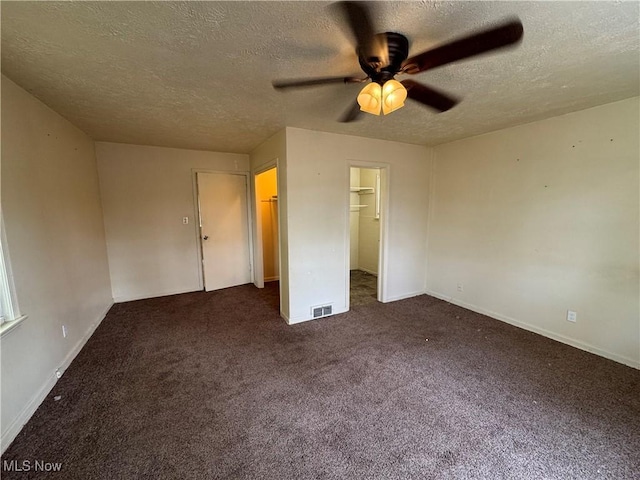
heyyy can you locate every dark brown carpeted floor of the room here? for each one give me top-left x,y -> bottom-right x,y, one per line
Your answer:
2,284 -> 640,480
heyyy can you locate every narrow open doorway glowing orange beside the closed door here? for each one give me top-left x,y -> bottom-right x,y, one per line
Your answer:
255,167 -> 280,290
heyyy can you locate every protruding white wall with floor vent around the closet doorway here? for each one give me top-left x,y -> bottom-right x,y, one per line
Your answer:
281,128 -> 431,323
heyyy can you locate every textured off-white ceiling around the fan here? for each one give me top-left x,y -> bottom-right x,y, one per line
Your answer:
1,1 -> 640,153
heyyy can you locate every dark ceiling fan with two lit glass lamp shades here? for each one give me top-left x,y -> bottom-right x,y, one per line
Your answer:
273,2 -> 523,122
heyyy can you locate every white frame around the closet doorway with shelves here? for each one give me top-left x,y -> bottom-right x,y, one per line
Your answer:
345,160 -> 391,310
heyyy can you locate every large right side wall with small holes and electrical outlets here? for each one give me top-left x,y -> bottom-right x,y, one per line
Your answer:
427,98 -> 640,367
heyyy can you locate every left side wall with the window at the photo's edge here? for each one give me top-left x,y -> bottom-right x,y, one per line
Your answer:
0,77 -> 113,451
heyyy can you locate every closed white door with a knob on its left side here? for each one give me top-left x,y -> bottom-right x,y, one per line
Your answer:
197,172 -> 251,292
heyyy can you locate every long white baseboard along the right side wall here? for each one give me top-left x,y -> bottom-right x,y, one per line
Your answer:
425,290 -> 640,369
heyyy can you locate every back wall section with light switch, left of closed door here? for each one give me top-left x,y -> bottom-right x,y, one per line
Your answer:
96,142 -> 249,302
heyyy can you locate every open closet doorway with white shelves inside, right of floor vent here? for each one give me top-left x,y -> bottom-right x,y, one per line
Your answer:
349,167 -> 381,306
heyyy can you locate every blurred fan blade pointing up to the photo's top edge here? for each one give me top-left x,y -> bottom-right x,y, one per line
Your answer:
335,2 -> 389,67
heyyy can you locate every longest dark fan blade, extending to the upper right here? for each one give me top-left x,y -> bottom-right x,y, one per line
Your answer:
403,20 -> 524,74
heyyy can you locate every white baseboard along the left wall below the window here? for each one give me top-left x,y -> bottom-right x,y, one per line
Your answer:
0,300 -> 114,453
